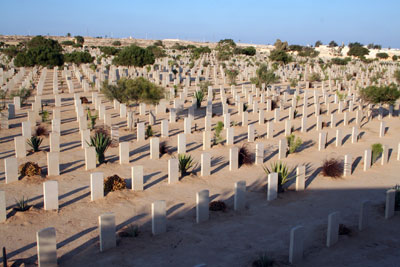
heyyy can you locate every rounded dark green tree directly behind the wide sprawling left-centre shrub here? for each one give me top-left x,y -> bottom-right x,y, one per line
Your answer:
113,45 -> 155,67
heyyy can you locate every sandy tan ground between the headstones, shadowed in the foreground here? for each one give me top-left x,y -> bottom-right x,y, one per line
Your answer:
0,70 -> 400,266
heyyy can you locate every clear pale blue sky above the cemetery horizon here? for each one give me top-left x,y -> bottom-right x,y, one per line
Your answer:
0,0 -> 400,48
